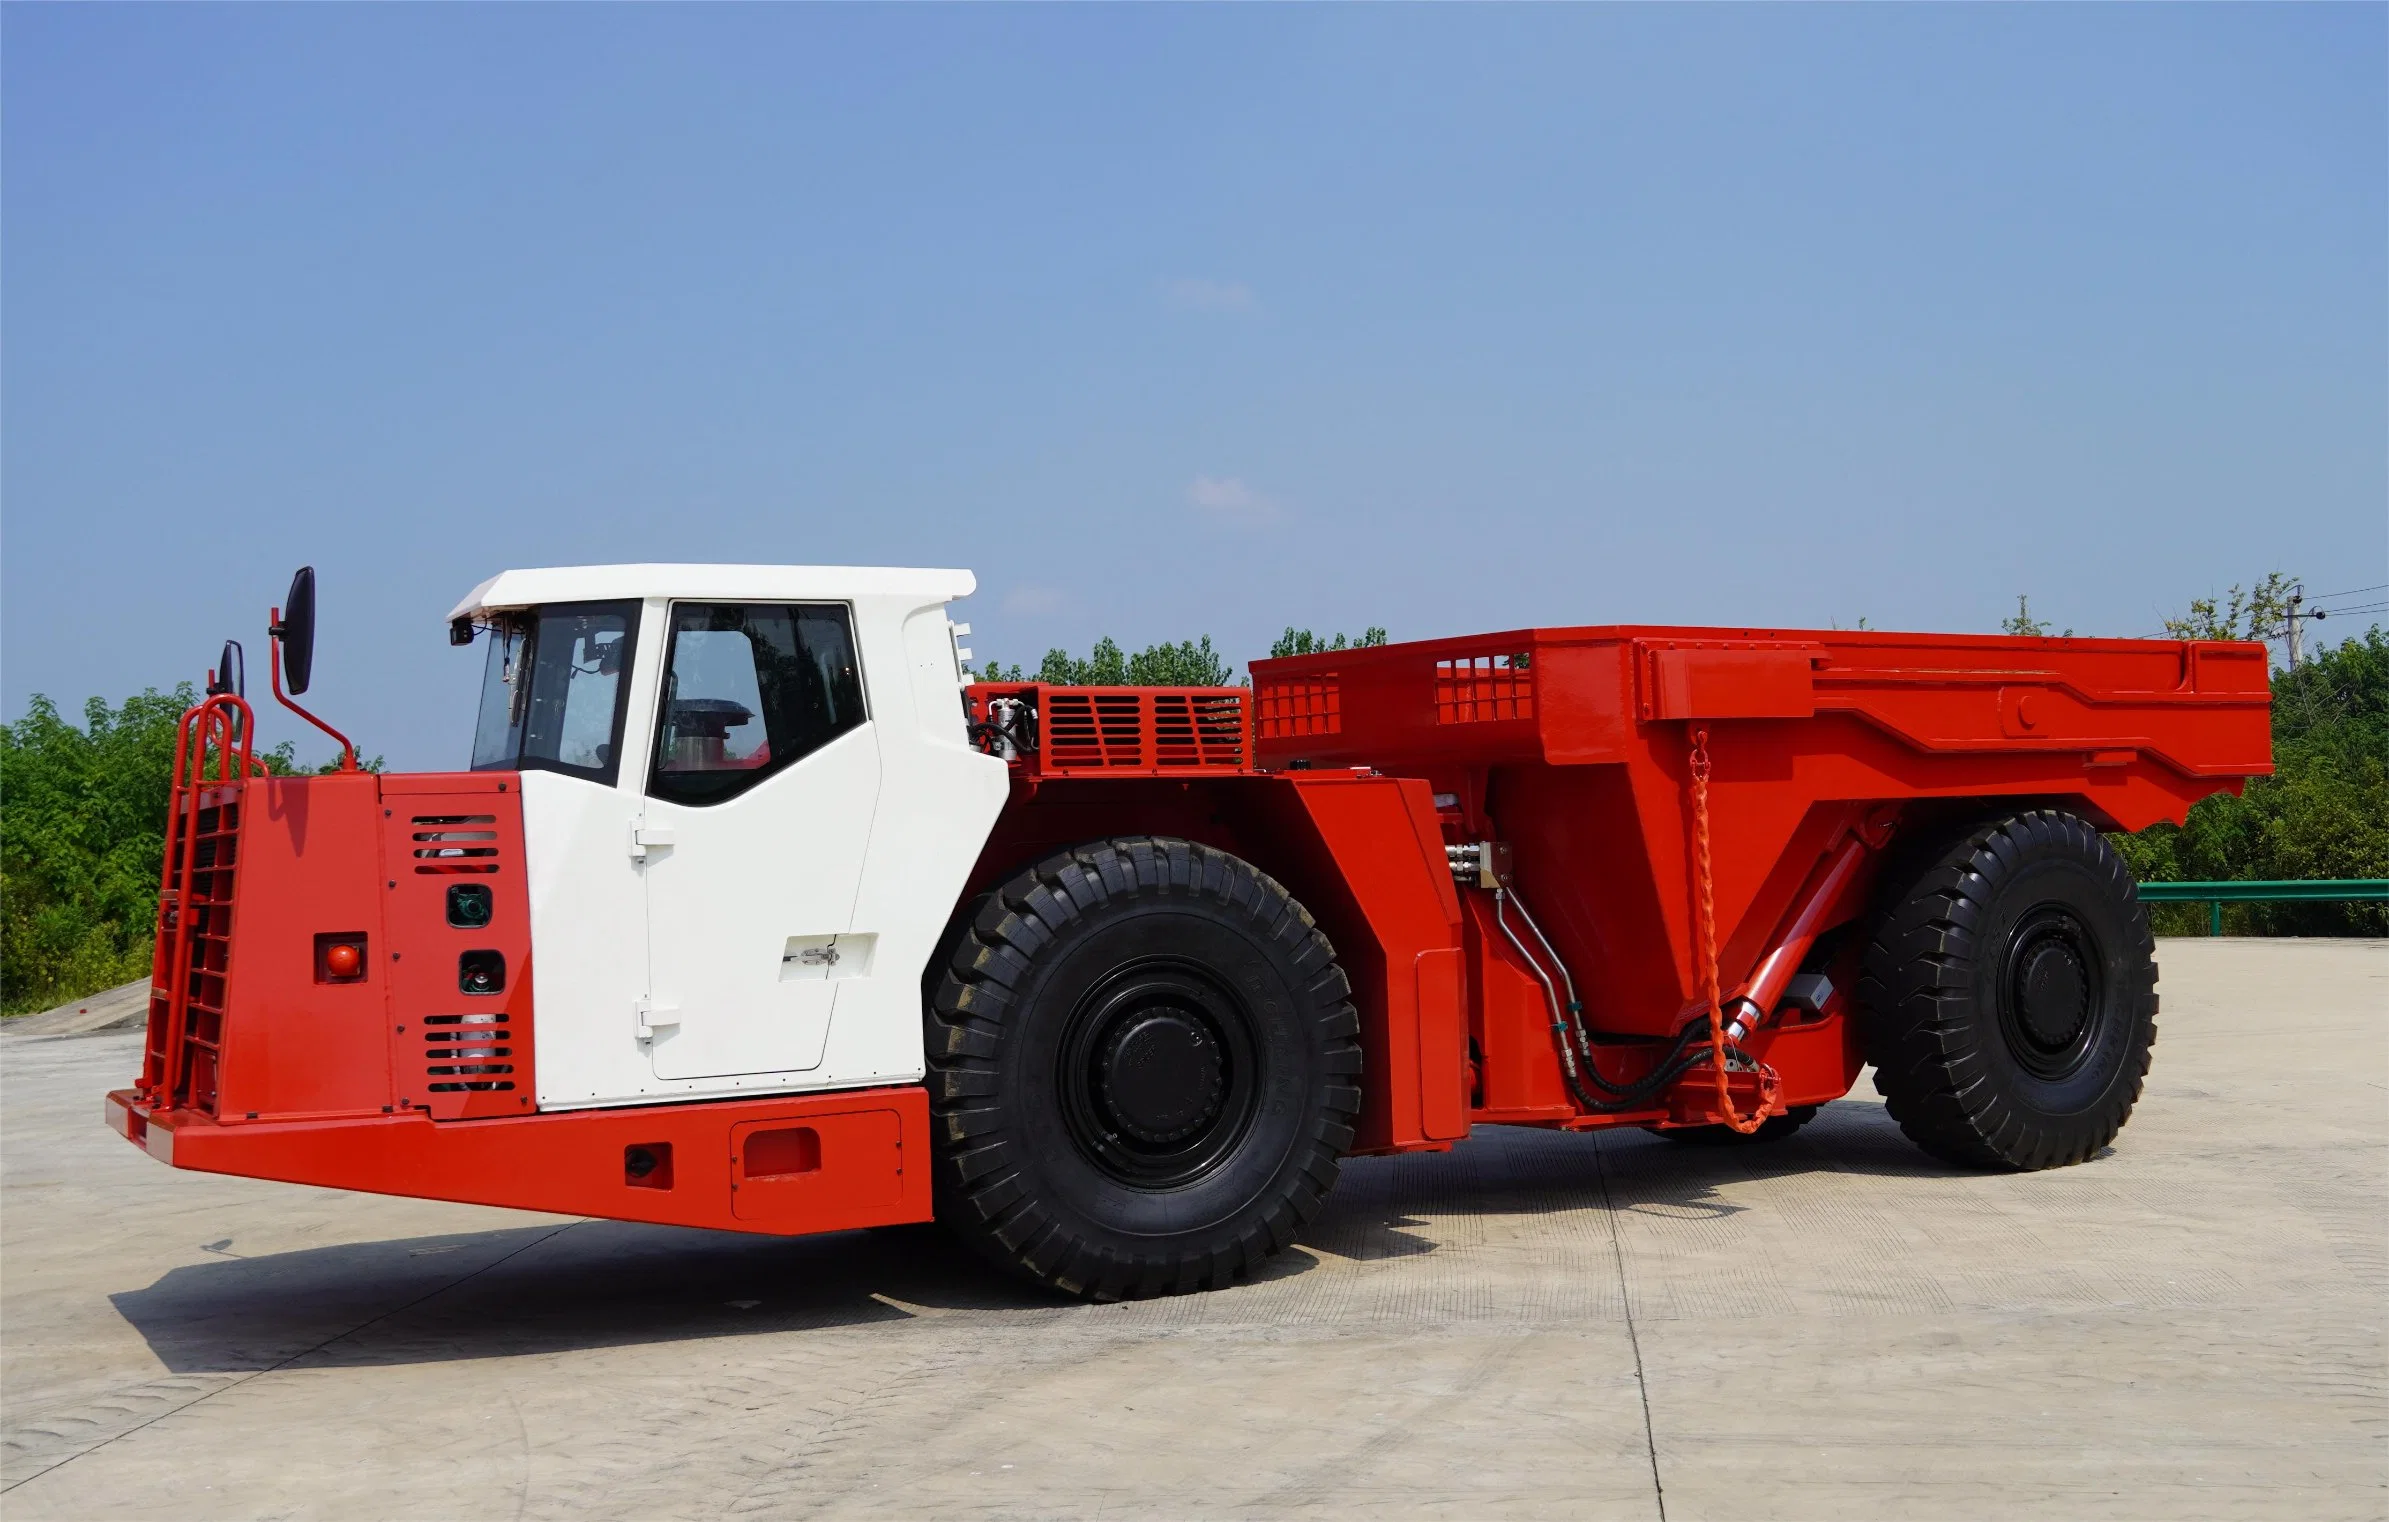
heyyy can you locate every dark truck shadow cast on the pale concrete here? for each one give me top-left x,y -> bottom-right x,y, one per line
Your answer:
112,1101 -> 1954,1374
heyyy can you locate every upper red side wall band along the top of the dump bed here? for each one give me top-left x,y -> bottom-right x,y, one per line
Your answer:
1254,628 -> 2272,802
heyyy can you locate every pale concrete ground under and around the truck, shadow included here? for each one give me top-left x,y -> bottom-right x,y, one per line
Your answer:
0,941 -> 2389,1522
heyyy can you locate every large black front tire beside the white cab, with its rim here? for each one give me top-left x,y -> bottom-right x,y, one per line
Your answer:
927,836 -> 1359,1300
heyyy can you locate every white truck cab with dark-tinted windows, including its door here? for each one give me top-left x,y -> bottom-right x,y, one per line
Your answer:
449,564 -> 1008,1111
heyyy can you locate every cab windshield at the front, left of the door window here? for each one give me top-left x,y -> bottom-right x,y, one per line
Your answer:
473,602 -> 638,786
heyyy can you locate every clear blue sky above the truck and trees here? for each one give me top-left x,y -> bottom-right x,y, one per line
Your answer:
0,5 -> 2389,767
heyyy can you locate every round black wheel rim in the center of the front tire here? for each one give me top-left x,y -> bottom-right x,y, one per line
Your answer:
1056,958 -> 1261,1190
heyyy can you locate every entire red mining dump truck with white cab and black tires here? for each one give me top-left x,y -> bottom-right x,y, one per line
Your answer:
108,566 -> 2270,1297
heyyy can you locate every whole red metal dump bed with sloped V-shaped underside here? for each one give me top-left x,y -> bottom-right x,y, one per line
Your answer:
1252,626 -> 2272,1035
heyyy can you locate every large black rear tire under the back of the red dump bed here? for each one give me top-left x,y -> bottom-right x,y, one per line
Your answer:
1859,810 -> 2157,1168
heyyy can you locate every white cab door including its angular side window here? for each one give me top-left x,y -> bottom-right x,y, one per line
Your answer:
631,602 -> 879,1082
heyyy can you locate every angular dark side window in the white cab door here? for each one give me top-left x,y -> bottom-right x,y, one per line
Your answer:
647,602 -> 865,803
